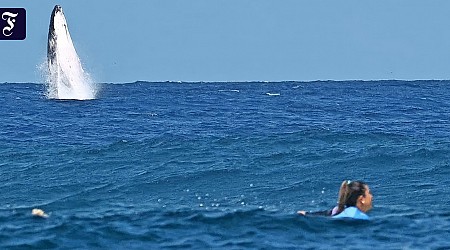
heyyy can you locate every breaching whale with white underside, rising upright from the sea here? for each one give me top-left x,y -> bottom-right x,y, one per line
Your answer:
47,5 -> 96,100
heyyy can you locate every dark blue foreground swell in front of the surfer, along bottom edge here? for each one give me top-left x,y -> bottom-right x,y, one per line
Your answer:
0,208 -> 449,249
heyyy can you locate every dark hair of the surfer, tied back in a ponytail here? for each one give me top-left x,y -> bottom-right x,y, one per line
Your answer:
338,181 -> 367,213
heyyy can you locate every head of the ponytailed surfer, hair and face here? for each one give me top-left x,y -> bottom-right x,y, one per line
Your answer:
338,181 -> 372,212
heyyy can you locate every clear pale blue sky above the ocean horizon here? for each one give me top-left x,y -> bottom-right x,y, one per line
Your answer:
0,0 -> 450,83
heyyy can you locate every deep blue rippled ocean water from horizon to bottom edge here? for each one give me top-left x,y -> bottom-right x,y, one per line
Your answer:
0,81 -> 450,249
